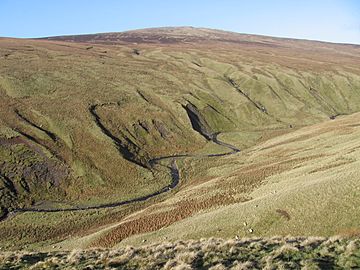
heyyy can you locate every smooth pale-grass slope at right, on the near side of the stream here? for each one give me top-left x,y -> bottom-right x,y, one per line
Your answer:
114,113 -> 360,245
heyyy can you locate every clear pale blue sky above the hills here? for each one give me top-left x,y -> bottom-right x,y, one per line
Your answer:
0,0 -> 360,44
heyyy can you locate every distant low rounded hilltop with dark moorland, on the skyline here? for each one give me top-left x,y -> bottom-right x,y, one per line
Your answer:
42,26 -> 360,46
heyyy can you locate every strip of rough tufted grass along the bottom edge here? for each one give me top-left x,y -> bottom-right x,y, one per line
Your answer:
0,237 -> 360,270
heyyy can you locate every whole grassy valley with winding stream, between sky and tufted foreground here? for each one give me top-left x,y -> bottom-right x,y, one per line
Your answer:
0,27 -> 360,252
